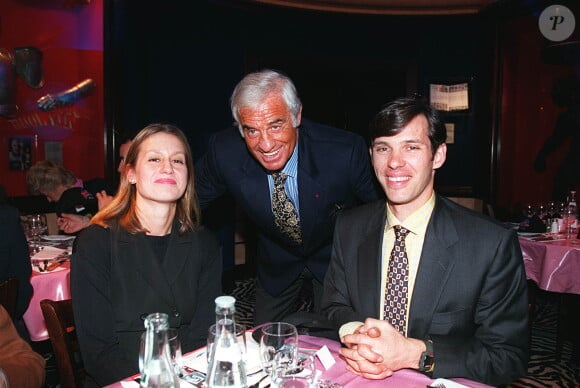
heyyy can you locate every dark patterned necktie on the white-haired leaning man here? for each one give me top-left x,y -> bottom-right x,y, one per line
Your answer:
272,172 -> 302,244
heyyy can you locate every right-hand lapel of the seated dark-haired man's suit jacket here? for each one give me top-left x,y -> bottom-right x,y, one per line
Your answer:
409,197 -> 458,338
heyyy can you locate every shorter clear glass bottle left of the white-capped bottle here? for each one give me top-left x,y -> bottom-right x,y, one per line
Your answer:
141,313 -> 179,388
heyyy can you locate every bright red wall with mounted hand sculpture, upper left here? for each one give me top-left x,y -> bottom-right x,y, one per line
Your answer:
0,0 -> 104,196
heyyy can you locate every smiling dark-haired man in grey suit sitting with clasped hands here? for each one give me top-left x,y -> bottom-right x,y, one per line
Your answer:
322,99 -> 529,386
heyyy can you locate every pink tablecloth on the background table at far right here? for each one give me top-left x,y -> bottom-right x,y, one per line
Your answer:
519,237 -> 580,294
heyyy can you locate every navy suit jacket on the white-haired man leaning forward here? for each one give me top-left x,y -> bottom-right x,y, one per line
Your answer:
195,120 -> 379,295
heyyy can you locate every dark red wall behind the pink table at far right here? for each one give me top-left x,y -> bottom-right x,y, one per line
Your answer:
498,12 -> 580,206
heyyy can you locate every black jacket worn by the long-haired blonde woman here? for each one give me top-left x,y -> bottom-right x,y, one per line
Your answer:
70,223 -> 222,385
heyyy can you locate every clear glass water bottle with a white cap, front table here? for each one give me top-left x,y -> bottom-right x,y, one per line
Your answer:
206,296 -> 248,388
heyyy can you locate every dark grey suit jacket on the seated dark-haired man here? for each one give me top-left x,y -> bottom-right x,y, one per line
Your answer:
322,196 -> 528,385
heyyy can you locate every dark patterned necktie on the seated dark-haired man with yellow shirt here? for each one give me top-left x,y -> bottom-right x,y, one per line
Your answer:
384,225 -> 409,335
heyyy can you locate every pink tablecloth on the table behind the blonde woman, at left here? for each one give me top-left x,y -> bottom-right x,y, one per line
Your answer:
24,263 -> 70,341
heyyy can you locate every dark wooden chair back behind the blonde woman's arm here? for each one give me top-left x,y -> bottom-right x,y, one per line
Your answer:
40,299 -> 85,388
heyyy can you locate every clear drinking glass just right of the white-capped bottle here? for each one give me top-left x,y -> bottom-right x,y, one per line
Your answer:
260,322 -> 298,376
